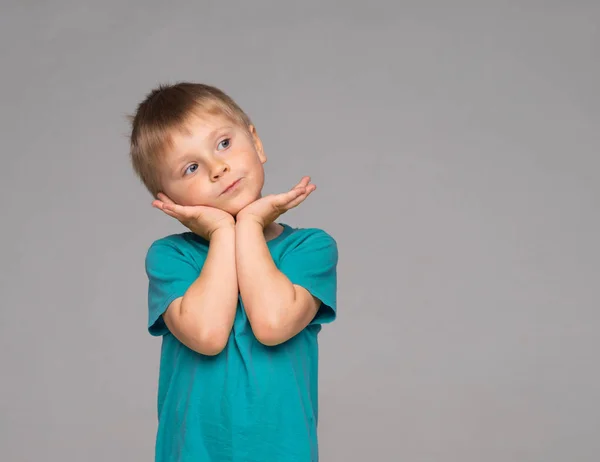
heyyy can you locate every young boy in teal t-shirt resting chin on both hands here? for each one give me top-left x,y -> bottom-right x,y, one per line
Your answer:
131,83 -> 338,462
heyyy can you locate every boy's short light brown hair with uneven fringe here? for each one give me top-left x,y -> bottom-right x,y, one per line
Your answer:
129,82 -> 252,197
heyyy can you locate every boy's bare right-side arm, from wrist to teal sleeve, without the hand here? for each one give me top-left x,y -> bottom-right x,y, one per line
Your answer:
235,218 -> 321,345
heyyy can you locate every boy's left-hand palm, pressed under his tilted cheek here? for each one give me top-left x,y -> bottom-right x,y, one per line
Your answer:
152,193 -> 235,241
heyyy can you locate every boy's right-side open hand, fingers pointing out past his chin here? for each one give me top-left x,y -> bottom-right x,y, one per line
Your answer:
237,176 -> 317,228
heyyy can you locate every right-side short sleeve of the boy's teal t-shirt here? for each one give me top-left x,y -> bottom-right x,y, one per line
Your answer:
279,230 -> 338,325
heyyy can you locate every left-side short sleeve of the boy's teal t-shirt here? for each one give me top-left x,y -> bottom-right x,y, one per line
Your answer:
146,242 -> 200,336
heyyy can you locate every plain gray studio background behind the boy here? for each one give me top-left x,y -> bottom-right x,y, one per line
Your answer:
0,0 -> 600,462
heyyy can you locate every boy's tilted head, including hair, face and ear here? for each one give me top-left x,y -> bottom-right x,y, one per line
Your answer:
130,83 -> 266,215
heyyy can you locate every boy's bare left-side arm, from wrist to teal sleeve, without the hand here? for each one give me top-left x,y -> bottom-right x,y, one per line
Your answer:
163,227 -> 238,355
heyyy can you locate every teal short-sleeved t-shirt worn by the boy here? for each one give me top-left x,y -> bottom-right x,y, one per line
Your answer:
146,224 -> 338,462
